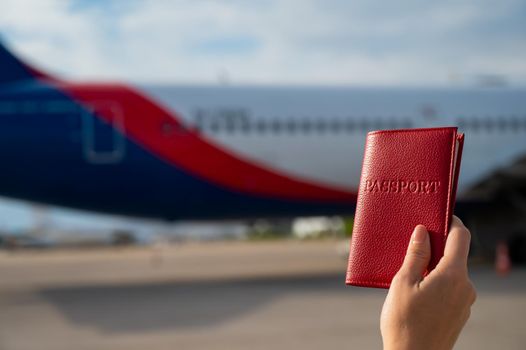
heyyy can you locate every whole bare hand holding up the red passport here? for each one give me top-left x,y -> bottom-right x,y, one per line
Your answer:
380,216 -> 476,350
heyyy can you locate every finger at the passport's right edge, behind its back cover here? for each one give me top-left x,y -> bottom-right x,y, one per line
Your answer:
443,215 -> 471,268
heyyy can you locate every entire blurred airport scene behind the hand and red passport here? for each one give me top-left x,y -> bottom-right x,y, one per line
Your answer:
0,0 -> 526,350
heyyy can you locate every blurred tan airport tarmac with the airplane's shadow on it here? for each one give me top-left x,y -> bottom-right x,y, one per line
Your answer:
0,240 -> 526,350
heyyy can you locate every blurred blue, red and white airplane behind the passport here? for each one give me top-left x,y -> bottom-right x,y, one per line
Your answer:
0,43 -> 526,260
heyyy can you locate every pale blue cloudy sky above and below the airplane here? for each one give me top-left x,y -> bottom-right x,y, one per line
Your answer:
0,0 -> 526,229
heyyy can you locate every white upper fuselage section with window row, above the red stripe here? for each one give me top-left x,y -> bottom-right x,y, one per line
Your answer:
140,86 -> 526,197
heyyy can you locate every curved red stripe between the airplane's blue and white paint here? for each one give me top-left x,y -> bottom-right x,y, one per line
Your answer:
55,83 -> 356,202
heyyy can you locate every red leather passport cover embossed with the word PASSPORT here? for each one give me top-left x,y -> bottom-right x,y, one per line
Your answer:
346,127 -> 464,288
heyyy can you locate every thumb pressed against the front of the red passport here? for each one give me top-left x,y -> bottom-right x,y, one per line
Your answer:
400,225 -> 431,284
